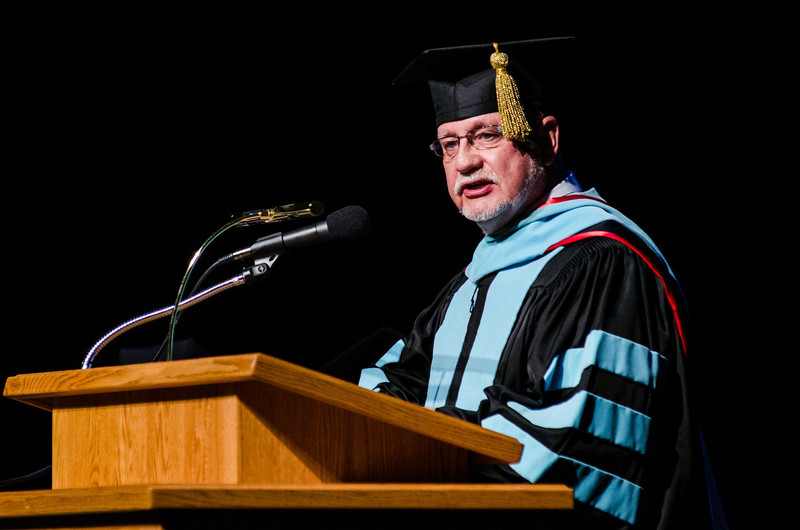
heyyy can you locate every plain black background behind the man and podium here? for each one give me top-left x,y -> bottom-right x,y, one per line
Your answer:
0,6 -> 796,528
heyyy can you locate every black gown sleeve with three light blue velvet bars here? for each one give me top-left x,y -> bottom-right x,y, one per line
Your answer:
472,239 -> 692,524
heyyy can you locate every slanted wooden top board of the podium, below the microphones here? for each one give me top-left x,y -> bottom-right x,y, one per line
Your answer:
3,353 -> 522,462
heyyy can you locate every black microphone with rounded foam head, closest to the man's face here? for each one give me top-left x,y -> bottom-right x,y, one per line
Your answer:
232,206 -> 370,260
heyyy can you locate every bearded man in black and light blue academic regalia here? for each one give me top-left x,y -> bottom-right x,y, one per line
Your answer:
359,41 -> 710,529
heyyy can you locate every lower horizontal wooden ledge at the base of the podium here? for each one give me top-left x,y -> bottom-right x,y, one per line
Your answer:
0,483 -> 573,517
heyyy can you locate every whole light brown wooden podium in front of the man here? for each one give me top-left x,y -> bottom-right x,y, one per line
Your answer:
0,353 -> 572,528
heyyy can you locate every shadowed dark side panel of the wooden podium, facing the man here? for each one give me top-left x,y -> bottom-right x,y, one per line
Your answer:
234,383 -> 469,484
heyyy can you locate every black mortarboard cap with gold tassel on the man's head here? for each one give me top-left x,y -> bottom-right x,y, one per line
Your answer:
394,37 -> 574,139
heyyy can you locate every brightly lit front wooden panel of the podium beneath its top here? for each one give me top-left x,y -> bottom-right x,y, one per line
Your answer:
52,385 -> 240,489
